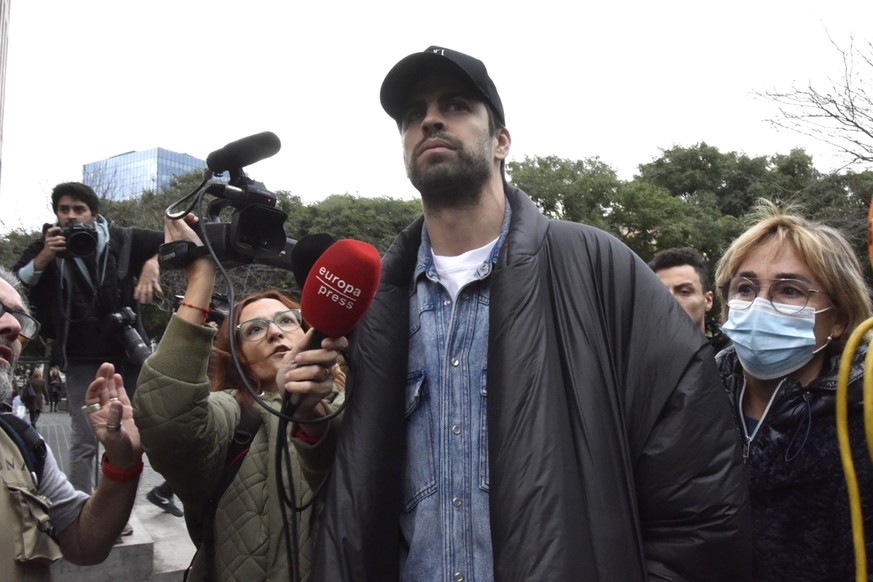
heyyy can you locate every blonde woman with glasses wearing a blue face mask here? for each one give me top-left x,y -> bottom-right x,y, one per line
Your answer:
716,200 -> 873,581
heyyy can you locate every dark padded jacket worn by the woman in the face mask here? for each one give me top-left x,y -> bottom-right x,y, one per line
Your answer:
718,346 -> 873,582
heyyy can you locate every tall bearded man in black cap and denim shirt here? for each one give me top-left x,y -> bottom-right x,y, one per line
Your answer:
313,47 -> 751,582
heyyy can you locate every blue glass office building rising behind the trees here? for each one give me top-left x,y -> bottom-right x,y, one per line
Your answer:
82,148 -> 206,200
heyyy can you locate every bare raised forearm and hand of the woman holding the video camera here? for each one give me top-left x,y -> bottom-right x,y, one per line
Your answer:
164,214 -> 215,325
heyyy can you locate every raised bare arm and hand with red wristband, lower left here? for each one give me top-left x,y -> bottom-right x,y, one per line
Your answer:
57,363 -> 142,564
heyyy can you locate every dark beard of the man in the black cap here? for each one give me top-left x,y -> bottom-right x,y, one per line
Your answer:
406,135 -> 492,210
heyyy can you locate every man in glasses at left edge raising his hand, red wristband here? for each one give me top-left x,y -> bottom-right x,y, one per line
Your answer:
0,267 -> 143,582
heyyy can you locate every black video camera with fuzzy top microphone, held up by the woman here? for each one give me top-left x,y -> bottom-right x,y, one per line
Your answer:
158,131 -> 297,270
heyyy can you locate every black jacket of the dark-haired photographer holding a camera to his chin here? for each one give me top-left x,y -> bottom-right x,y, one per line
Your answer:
12,226 -> 164,366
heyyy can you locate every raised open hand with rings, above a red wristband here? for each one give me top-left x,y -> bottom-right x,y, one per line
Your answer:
82,363 -> 142,469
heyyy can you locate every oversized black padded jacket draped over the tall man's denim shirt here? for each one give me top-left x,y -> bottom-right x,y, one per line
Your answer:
313,187 -> 751,582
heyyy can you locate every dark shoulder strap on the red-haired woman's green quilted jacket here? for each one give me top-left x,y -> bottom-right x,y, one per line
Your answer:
182,409 -> 261,580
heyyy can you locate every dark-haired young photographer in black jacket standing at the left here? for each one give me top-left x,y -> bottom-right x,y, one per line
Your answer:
13,182 -> 181,515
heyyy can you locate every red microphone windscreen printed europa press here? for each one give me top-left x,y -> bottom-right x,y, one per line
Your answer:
300,239 -> 382,337
